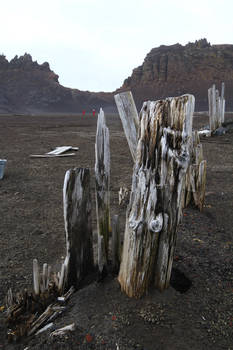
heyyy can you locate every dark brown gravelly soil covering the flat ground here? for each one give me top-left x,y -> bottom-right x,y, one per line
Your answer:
0,115 -> 233,350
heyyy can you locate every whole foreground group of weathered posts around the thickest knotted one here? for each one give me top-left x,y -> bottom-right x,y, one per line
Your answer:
62,92 -> 206,297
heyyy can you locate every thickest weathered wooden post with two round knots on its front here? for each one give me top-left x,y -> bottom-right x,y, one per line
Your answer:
118,95 -> 194,297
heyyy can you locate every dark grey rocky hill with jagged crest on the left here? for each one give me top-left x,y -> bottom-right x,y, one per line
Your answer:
0,54 -> 114,113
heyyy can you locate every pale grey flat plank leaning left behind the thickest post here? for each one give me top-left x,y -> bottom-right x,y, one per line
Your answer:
114,91 -> 139,162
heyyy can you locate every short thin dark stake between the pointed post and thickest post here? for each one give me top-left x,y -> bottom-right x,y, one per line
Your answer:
112,215 -> 121,272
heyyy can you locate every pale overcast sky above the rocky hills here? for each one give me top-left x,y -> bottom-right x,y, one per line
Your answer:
0,0 -> 233,91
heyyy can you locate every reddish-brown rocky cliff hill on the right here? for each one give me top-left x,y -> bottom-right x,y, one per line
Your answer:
120,39 -> 233,111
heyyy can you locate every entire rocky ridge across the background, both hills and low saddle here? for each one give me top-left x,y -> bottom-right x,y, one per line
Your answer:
0,39 -> 233,113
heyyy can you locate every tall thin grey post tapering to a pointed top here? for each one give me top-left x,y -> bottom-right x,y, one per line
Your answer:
95,109 -> 110,272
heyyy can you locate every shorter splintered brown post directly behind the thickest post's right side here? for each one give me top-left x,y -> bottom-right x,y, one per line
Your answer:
184,131 -> 206,211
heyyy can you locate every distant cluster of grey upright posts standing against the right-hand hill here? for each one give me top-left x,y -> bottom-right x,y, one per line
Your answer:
208,83 -> 225,133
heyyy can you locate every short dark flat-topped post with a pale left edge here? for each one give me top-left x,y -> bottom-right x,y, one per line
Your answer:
63,168 -> 94,288
